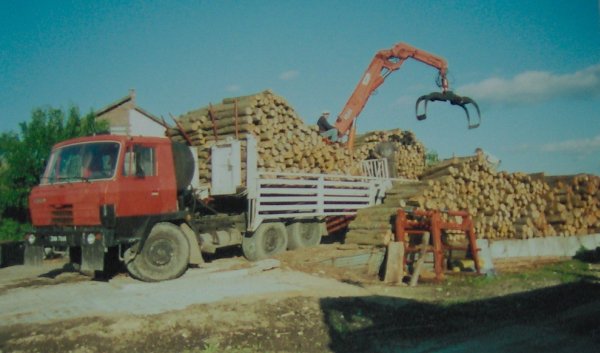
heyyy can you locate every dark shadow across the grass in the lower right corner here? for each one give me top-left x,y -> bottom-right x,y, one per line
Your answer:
321,281 -> 600,353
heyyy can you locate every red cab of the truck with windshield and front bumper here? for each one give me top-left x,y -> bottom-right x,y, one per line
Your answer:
26,135 -> 185,272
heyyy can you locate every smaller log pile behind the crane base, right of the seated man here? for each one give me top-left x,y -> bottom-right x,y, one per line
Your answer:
354,129 -> 425,179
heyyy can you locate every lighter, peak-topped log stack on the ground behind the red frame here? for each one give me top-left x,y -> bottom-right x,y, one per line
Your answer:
410,156 -> 557,239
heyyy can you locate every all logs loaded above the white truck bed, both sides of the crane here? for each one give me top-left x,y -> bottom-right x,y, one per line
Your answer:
167,90 -> 424,184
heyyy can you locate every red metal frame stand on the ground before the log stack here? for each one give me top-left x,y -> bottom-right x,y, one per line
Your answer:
395,209 -> 481,280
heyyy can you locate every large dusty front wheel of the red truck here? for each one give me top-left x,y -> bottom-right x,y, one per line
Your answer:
127,223 -> 190,282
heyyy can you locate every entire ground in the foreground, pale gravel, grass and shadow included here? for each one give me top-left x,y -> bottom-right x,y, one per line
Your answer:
0,245 -> 600,353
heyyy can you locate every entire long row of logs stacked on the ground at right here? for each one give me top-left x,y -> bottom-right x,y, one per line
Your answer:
347,156 -> 600,245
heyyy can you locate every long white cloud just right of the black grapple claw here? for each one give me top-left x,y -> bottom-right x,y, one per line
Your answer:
457,64 -> 600,104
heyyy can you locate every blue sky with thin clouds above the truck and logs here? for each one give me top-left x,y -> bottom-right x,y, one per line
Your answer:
0,0 -> 600,174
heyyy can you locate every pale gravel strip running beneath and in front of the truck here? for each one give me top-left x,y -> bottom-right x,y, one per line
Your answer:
0,254 -> 364,327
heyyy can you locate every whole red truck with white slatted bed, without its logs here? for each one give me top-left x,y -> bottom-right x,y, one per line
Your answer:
25,135 -> 391,281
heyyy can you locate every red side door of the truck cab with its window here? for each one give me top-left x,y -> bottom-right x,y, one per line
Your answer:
117,143 -> 176,217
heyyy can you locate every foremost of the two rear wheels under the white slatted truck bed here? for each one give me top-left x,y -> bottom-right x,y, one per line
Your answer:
242,223 -> 288,261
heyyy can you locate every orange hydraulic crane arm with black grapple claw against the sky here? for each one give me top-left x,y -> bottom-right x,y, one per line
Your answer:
335,43 -> 481,148
